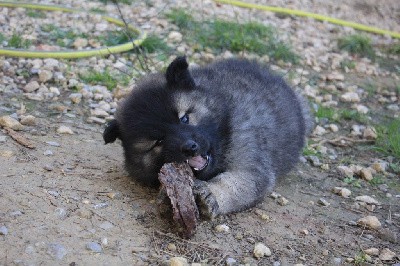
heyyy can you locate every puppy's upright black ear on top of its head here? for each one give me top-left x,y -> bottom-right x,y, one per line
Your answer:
165,56 -> 195,89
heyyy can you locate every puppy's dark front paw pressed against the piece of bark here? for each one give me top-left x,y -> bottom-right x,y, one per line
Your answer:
193,179 -> 219,219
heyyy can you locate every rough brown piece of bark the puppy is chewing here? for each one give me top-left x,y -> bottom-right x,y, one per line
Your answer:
158,163 -> 199,237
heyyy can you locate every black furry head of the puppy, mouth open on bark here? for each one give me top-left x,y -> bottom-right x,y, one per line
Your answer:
103,57 -> 226,184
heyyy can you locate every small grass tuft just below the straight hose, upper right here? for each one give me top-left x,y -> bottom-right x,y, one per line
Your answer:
338,34 -> 375,59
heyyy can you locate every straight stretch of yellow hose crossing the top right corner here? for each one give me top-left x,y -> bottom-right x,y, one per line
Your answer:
214,0 -> 400,39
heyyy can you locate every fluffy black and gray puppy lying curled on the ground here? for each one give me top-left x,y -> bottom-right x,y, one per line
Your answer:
105,58 -> 312,217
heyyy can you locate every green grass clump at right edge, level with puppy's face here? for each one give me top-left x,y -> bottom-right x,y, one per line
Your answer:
376,118 -> 400,159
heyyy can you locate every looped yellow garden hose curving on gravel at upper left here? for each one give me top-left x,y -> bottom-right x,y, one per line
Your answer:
0,2 -> 146,58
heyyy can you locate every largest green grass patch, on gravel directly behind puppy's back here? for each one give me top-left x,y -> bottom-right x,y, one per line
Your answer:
166,9 -> 299,63
